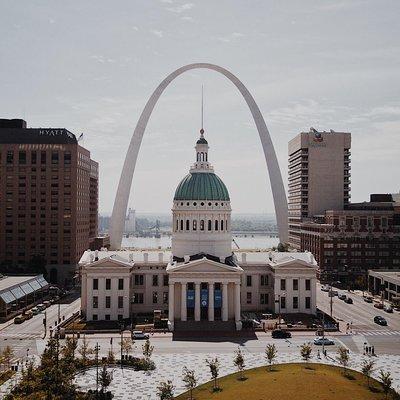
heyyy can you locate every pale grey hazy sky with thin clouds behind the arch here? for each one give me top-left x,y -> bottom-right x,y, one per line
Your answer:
0,0 -> 400,216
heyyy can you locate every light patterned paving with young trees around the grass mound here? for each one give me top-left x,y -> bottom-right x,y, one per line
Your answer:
76,350 -> 400,400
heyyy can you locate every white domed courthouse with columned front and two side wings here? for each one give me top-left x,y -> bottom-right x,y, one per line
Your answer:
80,130 -> 317,330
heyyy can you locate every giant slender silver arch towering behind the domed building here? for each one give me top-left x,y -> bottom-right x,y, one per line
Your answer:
110,63 -> 288,250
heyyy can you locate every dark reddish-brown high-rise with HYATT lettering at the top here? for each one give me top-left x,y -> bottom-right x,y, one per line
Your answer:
0,119 -> 98,285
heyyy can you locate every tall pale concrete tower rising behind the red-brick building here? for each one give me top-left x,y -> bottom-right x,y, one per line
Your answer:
289,128 -> 351,250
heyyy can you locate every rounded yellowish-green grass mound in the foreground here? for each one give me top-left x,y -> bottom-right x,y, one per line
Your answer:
176,364 -> 385,400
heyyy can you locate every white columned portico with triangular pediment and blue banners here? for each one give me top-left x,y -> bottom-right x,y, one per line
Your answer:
167,256 -> 243,330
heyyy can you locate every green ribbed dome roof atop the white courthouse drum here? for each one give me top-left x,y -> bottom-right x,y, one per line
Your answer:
174,172 -> 230,201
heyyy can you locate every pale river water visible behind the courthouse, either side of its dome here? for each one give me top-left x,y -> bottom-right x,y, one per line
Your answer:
122,234 -> 279,249
